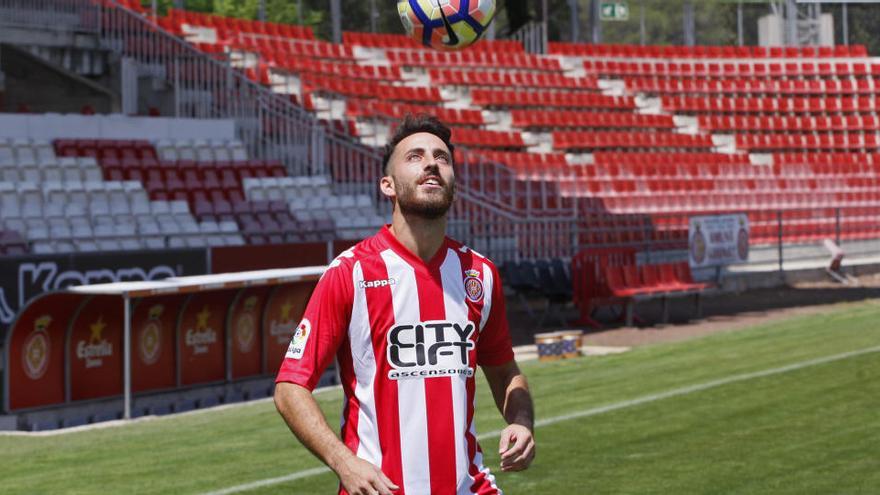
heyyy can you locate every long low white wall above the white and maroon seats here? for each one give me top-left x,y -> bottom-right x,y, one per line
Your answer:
0,113 -> 235,140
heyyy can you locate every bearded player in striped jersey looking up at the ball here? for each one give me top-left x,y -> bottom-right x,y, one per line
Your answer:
275,115 -> 535,495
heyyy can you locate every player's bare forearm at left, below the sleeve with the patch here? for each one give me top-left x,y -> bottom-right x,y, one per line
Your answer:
275,382 -> 354,472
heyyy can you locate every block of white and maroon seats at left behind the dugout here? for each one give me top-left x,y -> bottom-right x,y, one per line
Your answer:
0,111 -> 384,254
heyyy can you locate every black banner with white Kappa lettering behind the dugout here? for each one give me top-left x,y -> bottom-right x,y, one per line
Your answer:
0,249 -> 208,326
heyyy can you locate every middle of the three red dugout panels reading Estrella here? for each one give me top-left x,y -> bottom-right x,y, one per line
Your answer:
177,290 -> 238,385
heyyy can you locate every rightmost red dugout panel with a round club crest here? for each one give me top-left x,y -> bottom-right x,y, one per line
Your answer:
226,287 -> 270,379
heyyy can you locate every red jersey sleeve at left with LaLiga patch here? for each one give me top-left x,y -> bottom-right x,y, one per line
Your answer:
275,256 -> 354,390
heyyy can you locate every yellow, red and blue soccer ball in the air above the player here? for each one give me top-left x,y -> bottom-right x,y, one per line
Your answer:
397,0 -> 495,50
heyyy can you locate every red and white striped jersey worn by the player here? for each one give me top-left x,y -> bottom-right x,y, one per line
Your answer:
276,226 -> 513,495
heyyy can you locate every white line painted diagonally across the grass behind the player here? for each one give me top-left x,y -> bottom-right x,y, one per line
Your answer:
199,346 -> 880,495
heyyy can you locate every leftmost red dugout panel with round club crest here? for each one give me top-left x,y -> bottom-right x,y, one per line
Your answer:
6,294 -> 83,410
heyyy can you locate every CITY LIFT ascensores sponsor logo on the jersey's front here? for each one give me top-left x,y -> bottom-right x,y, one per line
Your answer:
387,321 -> 475,380
